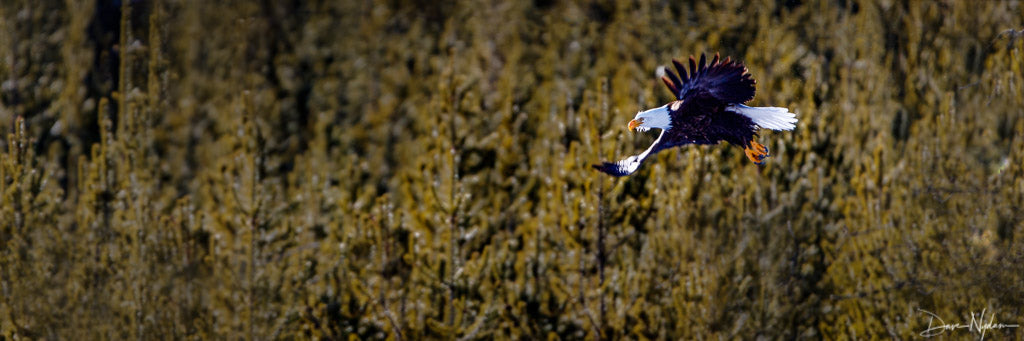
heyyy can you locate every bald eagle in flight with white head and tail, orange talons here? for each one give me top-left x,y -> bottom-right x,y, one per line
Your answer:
594,53 -> 797,176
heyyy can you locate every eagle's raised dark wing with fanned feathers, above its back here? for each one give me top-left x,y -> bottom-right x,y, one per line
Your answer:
662,53 -> 756,103
